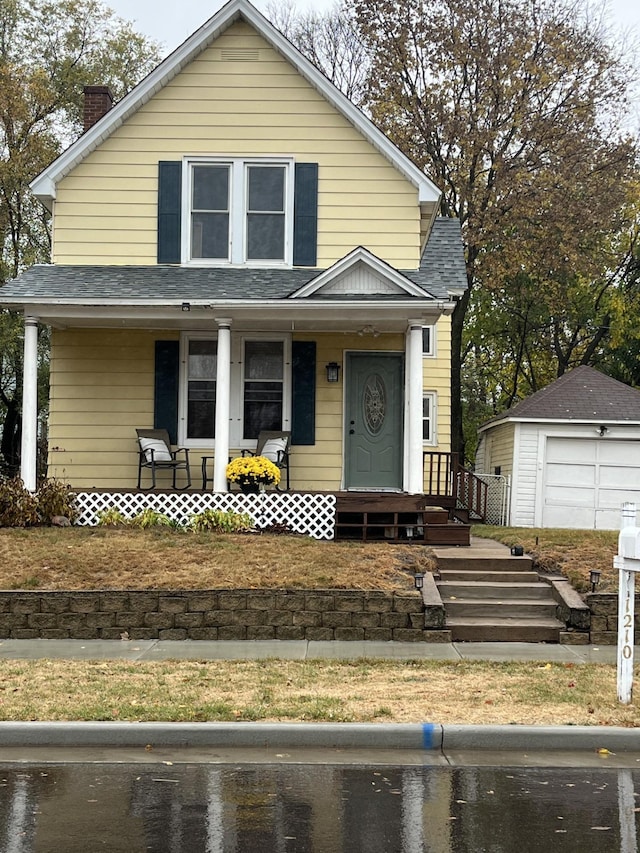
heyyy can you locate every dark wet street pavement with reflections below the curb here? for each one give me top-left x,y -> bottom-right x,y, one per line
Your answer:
0,752 -> 640,853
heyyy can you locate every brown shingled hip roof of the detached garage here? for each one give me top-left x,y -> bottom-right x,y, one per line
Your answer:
480,365 -> 640,431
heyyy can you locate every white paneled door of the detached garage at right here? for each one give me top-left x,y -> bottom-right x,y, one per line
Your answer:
542,438 -> 640,530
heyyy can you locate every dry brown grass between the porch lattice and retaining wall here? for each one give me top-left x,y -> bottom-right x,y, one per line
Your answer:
0,528 -> 433,590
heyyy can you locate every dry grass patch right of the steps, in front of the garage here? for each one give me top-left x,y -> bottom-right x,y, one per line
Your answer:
473,525 -> 618,592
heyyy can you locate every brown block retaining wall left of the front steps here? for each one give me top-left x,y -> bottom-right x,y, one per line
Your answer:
0,589 -> 450,642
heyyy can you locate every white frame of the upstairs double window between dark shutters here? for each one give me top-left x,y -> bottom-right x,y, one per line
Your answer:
181,156 -> 294,267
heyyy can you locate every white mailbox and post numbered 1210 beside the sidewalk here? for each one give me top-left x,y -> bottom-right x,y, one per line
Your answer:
613,503 -> 640,705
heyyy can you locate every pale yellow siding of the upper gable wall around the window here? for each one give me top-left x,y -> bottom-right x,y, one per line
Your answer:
54,23 -> 429,269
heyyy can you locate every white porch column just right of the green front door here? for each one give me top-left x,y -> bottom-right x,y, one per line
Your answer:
405,320 -> 424,494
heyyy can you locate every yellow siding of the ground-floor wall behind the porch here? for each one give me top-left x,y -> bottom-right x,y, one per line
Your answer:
49,327 -> 460,491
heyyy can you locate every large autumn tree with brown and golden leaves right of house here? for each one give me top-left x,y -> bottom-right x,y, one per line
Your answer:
272,0 -> 637,460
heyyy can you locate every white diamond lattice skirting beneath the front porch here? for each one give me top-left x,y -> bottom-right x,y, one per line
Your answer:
76,492 -> 336,539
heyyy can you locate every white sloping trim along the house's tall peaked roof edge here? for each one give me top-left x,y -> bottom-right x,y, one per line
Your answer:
30,0 -> 441,208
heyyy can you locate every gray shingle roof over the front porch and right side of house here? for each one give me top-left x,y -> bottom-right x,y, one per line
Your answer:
0,219 -> 466,305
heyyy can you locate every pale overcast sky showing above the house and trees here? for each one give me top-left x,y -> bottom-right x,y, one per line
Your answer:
105,0 -> 640,54
